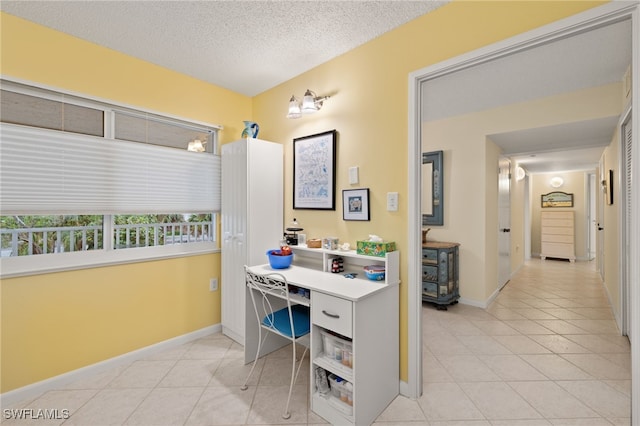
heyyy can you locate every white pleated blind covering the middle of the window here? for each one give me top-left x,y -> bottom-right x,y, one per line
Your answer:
0,123 -> 221,215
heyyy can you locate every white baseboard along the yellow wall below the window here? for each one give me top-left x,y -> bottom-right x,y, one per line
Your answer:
0,324 -> 222,407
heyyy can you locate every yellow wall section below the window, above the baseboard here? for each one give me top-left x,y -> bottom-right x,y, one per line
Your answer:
2,255 -> 220,391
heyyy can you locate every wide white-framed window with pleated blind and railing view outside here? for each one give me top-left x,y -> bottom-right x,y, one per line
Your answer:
0,81 -> 221,257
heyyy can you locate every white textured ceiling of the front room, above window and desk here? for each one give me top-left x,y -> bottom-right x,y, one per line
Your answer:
0,0 -> 448,96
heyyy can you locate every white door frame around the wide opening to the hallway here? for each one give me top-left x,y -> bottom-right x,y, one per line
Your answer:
408,1 -> 640,418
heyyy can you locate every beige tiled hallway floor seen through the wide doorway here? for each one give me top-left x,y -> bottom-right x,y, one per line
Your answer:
419,259 -> 631,425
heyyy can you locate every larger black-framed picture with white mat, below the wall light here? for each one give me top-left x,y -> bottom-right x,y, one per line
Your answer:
293,130 -> 337,210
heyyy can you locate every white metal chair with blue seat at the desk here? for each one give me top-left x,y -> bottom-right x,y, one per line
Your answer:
241,266 -> 311,419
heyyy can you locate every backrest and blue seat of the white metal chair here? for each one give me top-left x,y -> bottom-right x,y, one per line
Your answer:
245,266 -> 309,339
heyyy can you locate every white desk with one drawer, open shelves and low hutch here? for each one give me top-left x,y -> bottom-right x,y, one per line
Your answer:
245,251 -> 399,425
